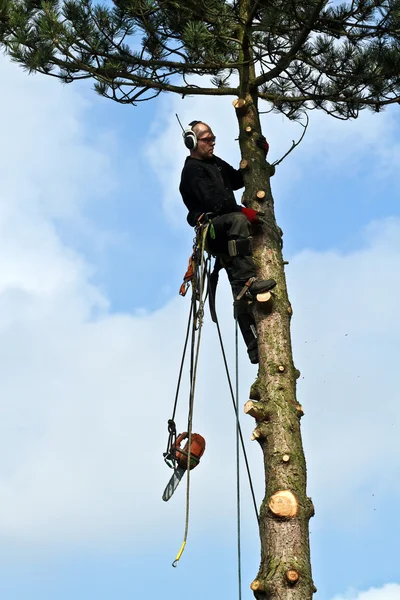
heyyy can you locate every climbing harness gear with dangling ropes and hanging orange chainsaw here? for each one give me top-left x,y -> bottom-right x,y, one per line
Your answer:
163,222 -> 259,580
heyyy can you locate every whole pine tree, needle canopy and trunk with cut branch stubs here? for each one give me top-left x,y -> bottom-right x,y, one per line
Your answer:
0,0 -> 400,600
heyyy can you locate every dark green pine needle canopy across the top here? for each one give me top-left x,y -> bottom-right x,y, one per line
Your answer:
0,0 -> 400,119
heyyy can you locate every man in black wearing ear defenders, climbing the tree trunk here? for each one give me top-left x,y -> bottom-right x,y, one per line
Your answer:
179,121 -> 276,363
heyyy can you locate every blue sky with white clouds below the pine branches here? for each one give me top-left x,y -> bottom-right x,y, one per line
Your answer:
0,51 -> 400,600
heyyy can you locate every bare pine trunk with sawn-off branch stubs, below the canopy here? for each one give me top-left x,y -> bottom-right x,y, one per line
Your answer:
233,88 -> 316,600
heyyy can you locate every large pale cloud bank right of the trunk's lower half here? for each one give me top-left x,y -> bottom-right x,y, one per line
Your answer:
289,219 -> 400,527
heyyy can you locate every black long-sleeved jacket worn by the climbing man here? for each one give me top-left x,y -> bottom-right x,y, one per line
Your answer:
179,156 -> 244,227
